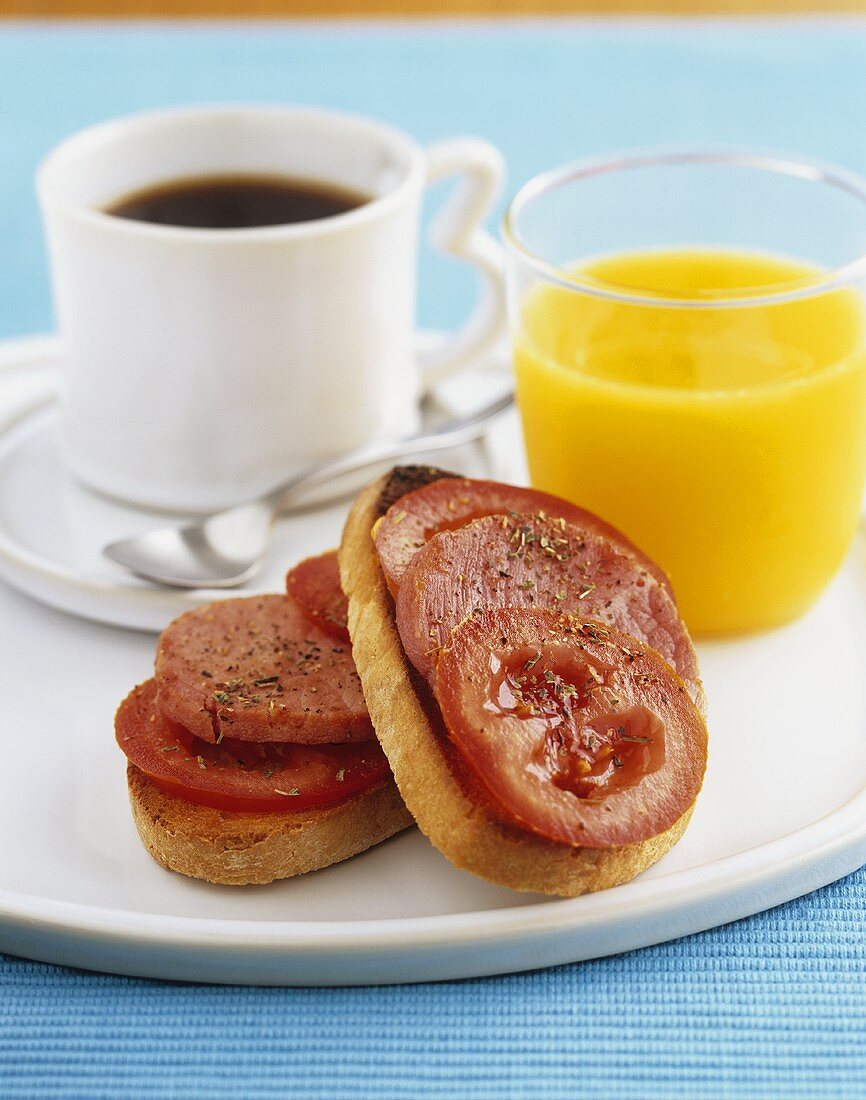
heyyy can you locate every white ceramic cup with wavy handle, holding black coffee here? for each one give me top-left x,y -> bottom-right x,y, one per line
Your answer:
37,107 -> 504,510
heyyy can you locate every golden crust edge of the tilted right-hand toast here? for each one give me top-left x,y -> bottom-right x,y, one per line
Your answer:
340,474 -> 693,898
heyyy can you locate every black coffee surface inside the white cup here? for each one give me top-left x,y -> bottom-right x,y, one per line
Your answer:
105,175 -> 370,229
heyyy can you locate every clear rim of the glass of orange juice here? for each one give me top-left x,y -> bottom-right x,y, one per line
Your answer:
502,146 -> 866,309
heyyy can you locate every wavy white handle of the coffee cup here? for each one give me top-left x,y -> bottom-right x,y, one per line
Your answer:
419,138 -> 505,391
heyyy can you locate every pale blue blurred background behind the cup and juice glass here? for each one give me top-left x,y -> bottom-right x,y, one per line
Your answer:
0,22 -> 866,336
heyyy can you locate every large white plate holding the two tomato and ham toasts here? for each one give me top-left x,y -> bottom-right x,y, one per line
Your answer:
0,332 -> 866,985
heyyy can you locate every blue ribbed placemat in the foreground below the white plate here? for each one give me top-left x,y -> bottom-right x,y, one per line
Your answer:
0,871 -> 866,1100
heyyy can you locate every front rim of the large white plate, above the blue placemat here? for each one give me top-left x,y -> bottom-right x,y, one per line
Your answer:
0,787 -> 866,950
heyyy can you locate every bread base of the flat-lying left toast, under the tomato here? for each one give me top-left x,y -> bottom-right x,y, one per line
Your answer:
127,763 -> 413,886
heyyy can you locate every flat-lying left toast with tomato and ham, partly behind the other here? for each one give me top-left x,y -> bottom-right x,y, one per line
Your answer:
116,552 -> 412,884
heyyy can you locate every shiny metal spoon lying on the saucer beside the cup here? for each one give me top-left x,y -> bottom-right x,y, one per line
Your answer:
102,393 -> 514,589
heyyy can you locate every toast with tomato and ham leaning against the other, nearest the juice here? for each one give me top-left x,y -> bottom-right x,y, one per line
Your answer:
340,466 -> 706,895
